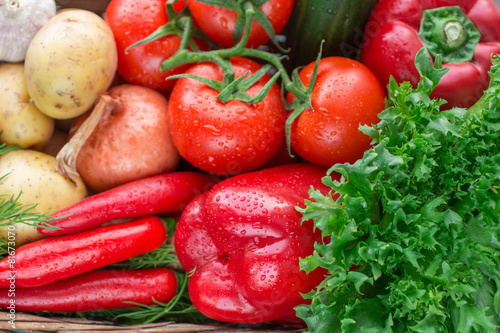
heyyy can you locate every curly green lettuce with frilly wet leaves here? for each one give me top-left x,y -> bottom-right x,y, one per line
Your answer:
296,49 -> 500,333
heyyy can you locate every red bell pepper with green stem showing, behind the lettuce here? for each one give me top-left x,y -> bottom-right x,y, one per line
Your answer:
361,0 -> 500,109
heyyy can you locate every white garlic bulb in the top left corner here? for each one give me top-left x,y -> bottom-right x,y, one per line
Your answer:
0,0 -> 56,62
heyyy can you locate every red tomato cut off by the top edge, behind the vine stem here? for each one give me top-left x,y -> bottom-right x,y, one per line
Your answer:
187,0 -> 295,48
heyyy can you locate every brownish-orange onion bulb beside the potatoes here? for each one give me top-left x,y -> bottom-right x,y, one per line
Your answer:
70,84 -> 179,192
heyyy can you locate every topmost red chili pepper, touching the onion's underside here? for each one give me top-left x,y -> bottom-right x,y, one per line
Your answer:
38,171 -> 214,236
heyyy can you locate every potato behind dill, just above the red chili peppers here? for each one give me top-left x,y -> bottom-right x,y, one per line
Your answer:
0,149 -> 87,246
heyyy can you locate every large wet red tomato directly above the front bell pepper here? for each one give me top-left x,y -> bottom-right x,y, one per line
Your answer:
168,57 -> 286,175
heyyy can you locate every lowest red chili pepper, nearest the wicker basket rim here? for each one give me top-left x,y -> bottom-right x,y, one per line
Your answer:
0,268 -> 177,312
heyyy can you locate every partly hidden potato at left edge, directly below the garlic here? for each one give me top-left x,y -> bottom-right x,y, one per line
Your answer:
0,63 -> 54,148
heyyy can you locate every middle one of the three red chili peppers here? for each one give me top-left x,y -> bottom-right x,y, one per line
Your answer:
0,216 -> 167,288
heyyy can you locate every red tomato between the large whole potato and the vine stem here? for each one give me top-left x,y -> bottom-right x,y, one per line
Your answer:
105,0 -> 187,92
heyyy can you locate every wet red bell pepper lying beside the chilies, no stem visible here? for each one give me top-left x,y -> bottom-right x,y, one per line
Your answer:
174,164 -> 340,323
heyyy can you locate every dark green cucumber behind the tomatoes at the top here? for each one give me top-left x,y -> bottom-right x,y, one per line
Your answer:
285,0 -> 378,69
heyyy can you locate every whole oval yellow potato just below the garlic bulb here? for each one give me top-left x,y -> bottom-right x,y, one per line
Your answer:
24,9 -> 118,119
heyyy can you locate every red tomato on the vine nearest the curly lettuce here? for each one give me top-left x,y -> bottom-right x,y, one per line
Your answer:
287,57 -> 385,167
